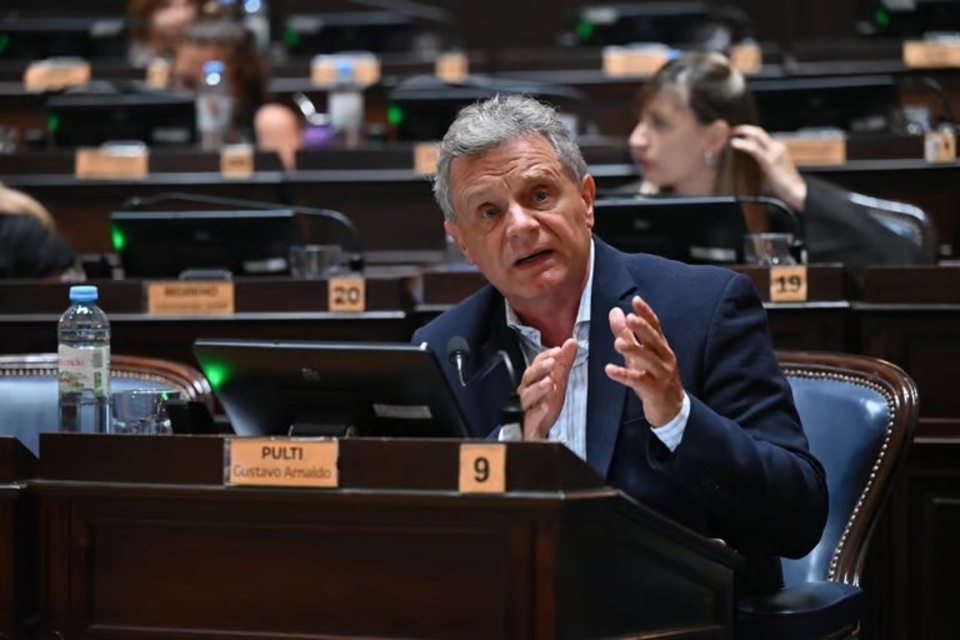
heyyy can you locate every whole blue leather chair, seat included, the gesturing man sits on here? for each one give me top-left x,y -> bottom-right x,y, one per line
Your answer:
737,352 -> 918,640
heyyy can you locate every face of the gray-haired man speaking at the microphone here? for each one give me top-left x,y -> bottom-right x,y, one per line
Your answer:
444,136 -> 595,307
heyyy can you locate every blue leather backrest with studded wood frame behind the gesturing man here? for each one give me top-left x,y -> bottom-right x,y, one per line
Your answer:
778,352 -> 918,586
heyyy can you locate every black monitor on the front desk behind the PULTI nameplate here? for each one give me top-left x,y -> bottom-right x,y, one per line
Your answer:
193,340 -> 468,438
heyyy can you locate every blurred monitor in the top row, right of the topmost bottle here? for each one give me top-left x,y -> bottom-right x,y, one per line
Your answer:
283,11 -> 424,55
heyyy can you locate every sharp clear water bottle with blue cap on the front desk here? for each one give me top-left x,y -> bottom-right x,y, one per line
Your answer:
57,285 -> 110,433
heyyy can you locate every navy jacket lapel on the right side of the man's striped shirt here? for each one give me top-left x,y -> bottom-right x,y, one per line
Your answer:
587,237 -> 636,477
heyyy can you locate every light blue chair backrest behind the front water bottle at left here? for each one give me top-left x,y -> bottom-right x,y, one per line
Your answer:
0,353 -> 214,455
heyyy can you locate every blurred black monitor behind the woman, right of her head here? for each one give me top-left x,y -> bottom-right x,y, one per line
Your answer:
750,75 -> 902,133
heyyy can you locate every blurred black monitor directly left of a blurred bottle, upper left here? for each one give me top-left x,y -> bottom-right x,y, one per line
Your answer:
46,90 -> 197,147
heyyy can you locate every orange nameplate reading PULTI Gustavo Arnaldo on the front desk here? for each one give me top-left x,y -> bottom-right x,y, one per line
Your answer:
224,438 -> 340,488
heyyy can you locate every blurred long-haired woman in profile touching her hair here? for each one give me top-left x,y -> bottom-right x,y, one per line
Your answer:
618,53 -> 925,274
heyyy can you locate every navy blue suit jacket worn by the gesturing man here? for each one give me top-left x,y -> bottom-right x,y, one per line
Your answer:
413,237 -> 827,595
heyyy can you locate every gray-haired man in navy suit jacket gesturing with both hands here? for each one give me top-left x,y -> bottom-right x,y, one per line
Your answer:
413,97 -> 827,595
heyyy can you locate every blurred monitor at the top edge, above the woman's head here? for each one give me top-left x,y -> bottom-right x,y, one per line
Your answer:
568,1 -> 715,47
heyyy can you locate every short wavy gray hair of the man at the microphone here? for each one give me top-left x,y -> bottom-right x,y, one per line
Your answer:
433,95 -> 587,221
